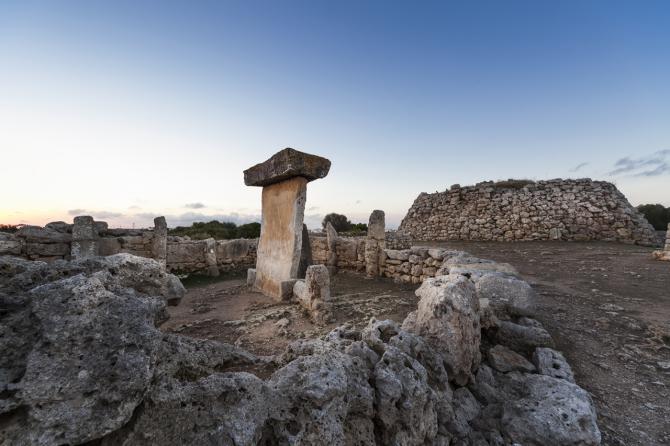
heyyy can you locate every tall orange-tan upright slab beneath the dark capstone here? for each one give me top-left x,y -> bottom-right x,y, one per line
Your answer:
255,177 -> 307,299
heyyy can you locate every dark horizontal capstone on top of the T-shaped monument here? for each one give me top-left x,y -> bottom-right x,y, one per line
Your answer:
244,148 -> 330,186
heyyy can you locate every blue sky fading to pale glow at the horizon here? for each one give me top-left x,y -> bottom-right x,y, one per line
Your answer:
0,0 -> 670,227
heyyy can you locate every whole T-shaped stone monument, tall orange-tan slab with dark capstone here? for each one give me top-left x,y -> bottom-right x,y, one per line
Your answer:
244,148 -> 330,300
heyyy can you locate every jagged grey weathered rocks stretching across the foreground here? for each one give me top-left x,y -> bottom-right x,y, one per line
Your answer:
0,252 -> 600,446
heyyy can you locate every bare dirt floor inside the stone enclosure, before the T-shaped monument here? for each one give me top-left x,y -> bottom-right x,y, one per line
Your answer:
161,271 -> 417,355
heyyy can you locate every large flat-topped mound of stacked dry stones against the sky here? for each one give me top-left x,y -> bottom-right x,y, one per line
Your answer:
399,179 -> 656,245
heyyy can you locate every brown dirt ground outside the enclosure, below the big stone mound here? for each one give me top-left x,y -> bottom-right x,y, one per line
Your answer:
420,242 -> 670,446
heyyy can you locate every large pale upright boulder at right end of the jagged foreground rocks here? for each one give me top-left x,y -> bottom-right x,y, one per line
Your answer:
402,275 -> 481,385
